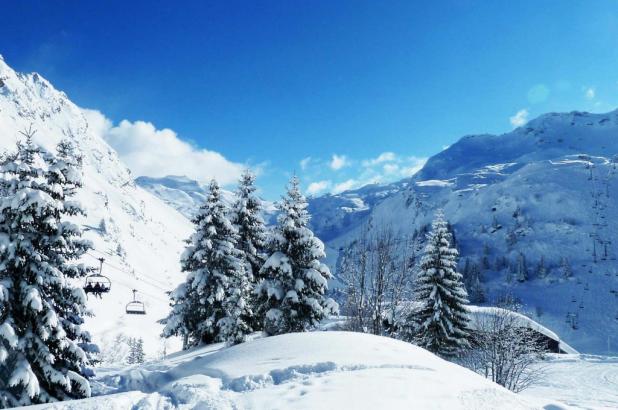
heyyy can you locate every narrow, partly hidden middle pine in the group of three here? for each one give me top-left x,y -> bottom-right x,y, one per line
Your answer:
231,169 -> 267,330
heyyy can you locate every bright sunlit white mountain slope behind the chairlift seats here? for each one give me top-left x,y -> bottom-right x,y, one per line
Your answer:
0,58 -> 191,357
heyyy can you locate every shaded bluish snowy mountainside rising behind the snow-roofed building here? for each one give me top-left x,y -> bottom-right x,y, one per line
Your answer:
329,111 -> 618,354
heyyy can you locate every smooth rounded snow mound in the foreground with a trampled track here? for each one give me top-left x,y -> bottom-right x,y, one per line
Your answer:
20,332 -> 552,410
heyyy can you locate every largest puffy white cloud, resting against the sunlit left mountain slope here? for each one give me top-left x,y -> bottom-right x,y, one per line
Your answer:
83,109 -> 245,185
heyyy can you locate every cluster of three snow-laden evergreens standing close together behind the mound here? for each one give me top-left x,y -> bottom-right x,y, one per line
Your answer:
161,170 -> 338,349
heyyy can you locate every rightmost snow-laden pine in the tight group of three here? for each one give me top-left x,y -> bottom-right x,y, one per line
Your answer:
258,176 -> 338,335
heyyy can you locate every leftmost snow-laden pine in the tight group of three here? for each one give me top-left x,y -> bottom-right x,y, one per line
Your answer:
163,180 -> 251,348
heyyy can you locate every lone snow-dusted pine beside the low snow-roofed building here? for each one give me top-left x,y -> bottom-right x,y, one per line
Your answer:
406,210 -> 469,357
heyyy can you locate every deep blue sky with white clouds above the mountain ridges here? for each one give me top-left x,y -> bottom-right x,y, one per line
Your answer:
0,0 -> 618,198
